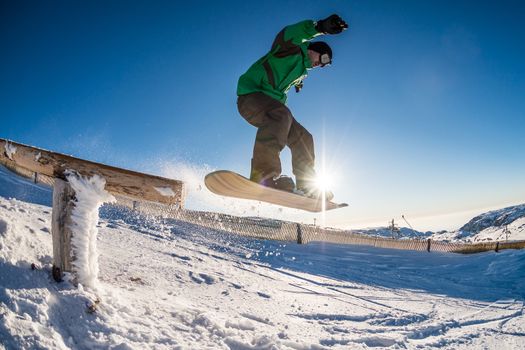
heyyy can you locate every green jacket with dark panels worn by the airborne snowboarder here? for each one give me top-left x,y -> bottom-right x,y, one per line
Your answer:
237,20 -> 322,103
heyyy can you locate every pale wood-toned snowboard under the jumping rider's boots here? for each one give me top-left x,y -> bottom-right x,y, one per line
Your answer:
204,170 -> 348,213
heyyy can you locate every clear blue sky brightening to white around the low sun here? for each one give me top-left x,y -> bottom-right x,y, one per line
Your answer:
0,1 -> 525,230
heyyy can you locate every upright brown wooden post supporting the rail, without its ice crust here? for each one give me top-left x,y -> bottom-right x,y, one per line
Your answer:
51,178 -> 75,282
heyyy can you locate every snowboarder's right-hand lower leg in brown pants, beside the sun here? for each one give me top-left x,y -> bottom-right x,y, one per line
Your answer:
287,118 -> 315,188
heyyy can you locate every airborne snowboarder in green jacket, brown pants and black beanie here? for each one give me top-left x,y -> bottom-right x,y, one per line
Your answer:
237,14 -> 348,200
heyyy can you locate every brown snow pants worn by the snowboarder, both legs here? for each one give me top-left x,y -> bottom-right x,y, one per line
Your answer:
237,92 -> 315,187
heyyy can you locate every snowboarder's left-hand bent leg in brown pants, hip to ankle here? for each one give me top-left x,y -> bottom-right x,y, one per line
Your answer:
237,93 -> 293,183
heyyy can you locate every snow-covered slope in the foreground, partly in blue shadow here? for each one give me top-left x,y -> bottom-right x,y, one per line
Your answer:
0,167 -> 525,349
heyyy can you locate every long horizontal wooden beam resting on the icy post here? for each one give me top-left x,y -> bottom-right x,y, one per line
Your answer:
0,139 -> 185,208
